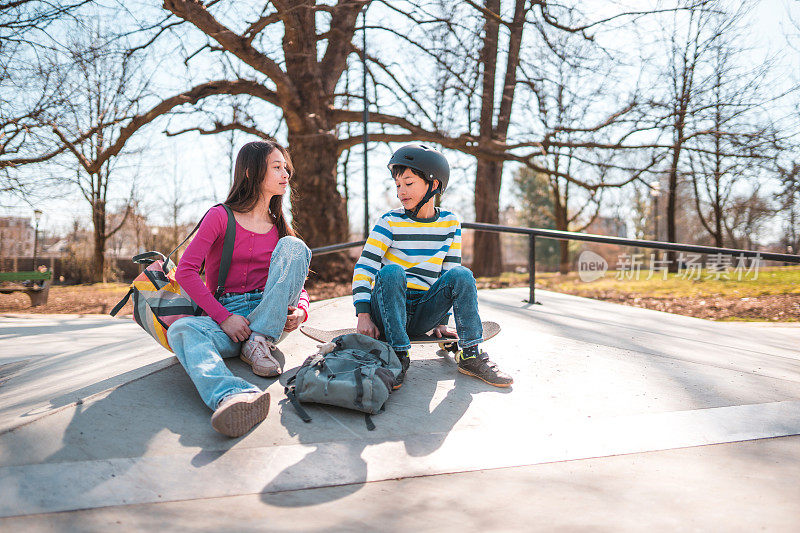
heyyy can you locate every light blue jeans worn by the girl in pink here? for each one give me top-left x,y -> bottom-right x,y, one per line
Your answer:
167,237 -> 311,409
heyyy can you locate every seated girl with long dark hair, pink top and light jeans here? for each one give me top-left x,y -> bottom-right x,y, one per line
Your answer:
167,142 -> 311,437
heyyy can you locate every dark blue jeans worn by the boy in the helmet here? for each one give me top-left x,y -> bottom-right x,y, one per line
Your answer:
370,265 -> 483,351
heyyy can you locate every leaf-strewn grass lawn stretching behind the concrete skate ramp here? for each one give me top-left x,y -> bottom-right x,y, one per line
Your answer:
0,267 -> 800,322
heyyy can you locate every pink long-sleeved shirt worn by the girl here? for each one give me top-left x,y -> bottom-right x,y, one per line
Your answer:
175,205 -> 308,324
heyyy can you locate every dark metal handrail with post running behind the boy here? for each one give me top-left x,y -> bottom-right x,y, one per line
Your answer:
311,222 -> 800,302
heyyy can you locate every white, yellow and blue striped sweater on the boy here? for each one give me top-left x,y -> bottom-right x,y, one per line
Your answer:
353,208 -> 461,313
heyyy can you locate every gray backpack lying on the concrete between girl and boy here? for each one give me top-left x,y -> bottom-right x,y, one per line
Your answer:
285,333 -> 402,430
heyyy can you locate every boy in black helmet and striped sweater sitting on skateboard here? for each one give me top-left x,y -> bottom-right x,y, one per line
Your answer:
353,144 -> 513,387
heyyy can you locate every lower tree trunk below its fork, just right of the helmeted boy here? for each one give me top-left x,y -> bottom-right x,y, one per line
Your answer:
472,159 -> 503,276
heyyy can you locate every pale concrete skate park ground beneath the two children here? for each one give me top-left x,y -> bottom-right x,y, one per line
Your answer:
0,289 -> 800,531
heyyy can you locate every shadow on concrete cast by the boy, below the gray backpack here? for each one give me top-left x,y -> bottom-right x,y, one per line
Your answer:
261,351 -> 511,507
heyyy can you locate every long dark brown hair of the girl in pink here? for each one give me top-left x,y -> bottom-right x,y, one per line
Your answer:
225,141 -> 296,237
